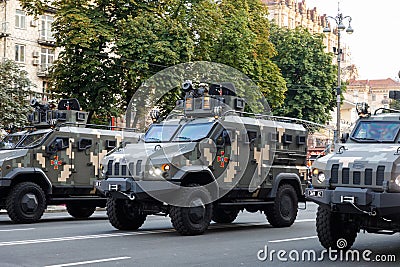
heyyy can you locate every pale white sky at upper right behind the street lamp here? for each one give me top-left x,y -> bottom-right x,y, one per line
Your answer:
304,0 -> 400,80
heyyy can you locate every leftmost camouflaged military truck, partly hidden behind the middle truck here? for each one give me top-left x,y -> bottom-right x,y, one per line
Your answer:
0,99 -> 139,223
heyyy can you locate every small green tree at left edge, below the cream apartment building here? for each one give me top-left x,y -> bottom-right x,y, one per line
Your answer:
0,60 -> 33,129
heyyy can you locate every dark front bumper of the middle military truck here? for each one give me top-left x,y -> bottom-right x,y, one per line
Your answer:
96,178 -> 180,200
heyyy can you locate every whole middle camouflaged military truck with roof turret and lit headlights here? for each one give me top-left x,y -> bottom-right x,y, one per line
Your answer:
96,81 -> 307,235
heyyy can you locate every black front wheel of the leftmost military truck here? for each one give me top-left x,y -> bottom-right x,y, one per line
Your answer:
6,182 -> 46,223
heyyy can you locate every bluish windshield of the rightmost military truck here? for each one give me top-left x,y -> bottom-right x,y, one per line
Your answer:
350,120 -> 400,143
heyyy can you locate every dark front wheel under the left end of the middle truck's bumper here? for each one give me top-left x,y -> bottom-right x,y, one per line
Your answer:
106,197 -> 147,230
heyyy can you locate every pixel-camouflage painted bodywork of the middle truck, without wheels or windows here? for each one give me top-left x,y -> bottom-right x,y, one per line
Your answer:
102,116 -> 307,195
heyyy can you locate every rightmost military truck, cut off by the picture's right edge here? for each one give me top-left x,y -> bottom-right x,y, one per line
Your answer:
306,92 -> 400,249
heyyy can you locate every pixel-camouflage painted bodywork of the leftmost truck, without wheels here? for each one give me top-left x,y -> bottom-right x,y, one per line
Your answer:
0,126 -> 139,185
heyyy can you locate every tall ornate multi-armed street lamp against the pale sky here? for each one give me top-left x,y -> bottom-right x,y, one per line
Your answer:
323,10 -> 354,143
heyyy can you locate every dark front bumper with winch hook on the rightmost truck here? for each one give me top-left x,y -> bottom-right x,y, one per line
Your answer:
306,187 -> 400,216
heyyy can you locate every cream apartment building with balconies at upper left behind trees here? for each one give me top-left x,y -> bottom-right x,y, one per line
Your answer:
0,0 -> 59,100
